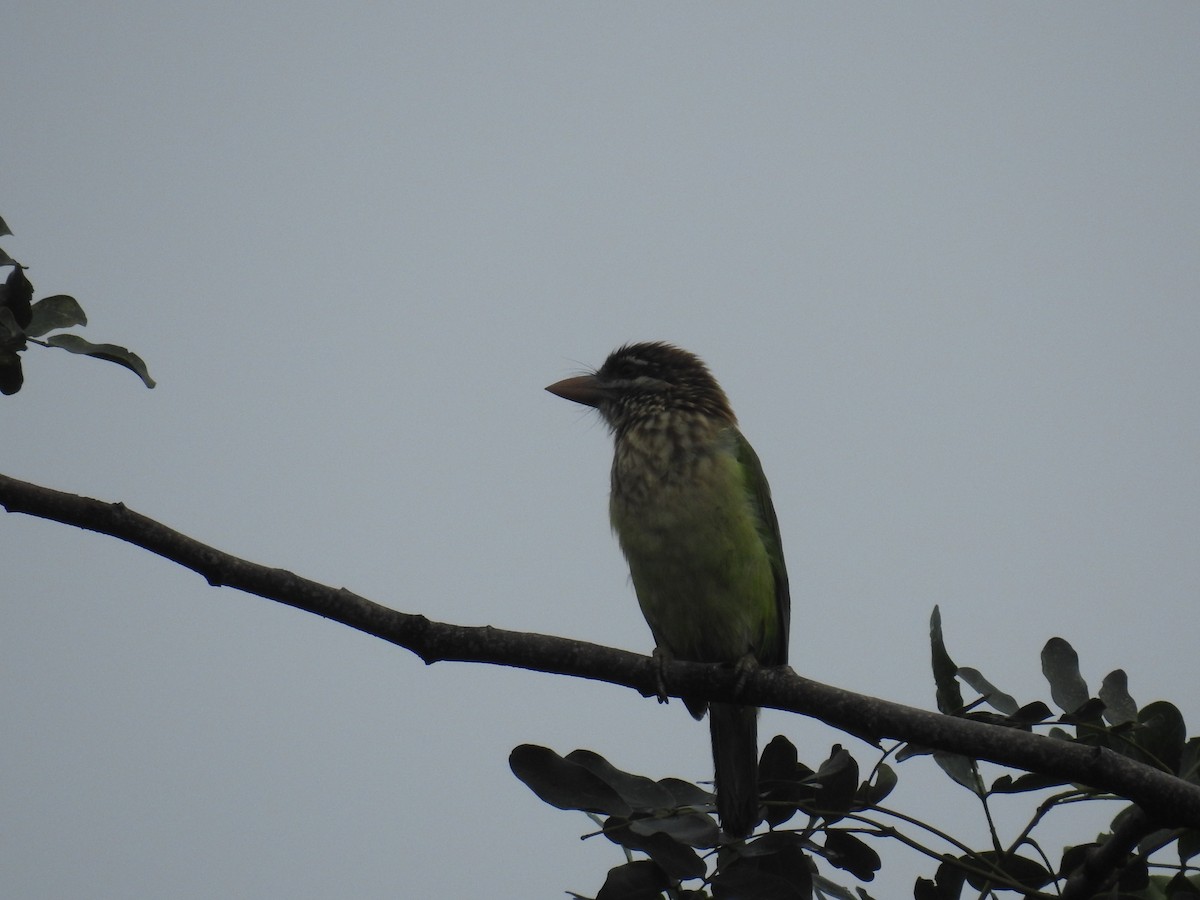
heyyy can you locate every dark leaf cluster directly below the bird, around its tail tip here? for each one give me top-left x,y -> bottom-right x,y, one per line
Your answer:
509,736 -> 895,900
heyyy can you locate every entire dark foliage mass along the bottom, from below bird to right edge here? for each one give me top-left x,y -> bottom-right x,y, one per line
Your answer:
509,610 -> 1200,900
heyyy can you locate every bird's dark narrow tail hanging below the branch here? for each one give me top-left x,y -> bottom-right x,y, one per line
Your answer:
708,703 -> 760,838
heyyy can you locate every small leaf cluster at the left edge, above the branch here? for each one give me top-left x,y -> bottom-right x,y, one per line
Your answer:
0,218 -> 155,394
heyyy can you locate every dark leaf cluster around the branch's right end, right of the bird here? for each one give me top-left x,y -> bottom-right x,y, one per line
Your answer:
898,608 -> 1200,900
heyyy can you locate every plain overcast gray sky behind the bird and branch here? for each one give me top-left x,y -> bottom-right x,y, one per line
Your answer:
0,0 -> 1200,898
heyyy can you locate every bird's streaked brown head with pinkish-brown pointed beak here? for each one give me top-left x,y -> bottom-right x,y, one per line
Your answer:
546,342 -> 737,434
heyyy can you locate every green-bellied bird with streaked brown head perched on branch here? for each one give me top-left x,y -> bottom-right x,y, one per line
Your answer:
546,341 -> 791,839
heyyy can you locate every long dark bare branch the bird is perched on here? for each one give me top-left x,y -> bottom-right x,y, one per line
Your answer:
0,475 -> 1200,828
